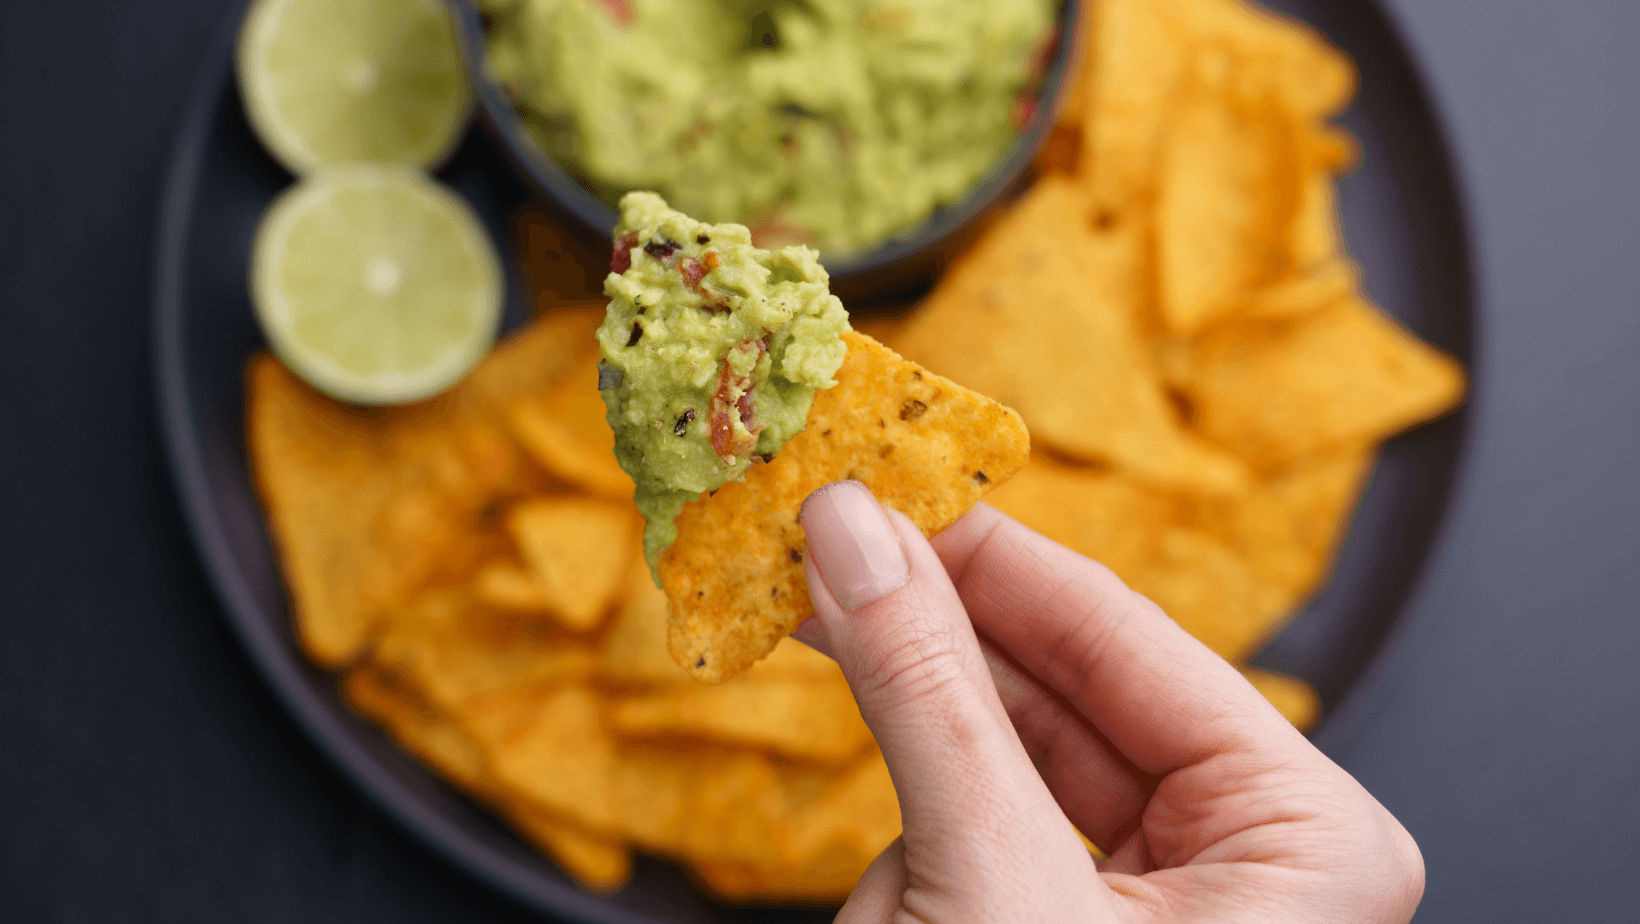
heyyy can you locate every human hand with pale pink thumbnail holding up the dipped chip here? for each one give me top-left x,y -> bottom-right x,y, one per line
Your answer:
795,481 -> 1424,924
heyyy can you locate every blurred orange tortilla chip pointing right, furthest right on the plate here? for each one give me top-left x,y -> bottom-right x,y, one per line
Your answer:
1191,299 -> 1465,468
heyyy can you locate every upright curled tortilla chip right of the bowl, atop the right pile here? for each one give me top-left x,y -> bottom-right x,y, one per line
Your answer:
1155,89 -> 1299,335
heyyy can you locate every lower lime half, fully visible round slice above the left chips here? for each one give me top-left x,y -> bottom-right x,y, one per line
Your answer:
251,164 -> 502,404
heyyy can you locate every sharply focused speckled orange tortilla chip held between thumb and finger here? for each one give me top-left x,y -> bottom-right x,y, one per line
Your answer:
658,332 -> 1030,683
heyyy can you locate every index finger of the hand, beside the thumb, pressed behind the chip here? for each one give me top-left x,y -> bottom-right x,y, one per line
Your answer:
933,504 -> 1302,776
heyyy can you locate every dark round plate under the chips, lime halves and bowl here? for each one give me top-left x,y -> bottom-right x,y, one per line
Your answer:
154,0 -> 1476,924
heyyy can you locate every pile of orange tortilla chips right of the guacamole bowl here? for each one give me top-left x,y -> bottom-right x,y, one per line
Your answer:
876,0 -> 1465,682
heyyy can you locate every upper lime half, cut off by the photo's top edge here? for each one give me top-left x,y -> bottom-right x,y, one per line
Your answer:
238,0 -> 472,176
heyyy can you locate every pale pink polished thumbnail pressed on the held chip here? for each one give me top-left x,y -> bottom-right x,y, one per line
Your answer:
802,481 -> 912,609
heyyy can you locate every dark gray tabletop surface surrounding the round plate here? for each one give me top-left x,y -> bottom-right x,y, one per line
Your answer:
0,0 -> 1640,922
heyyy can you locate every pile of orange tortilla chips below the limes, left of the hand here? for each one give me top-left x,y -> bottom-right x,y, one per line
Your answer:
249,305 -> 900,901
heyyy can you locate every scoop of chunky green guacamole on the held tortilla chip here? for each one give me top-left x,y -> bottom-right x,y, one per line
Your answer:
599,192 -> 848,568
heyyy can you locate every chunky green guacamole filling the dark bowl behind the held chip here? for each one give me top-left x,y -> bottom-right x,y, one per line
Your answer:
484,0 -> 1058,256
